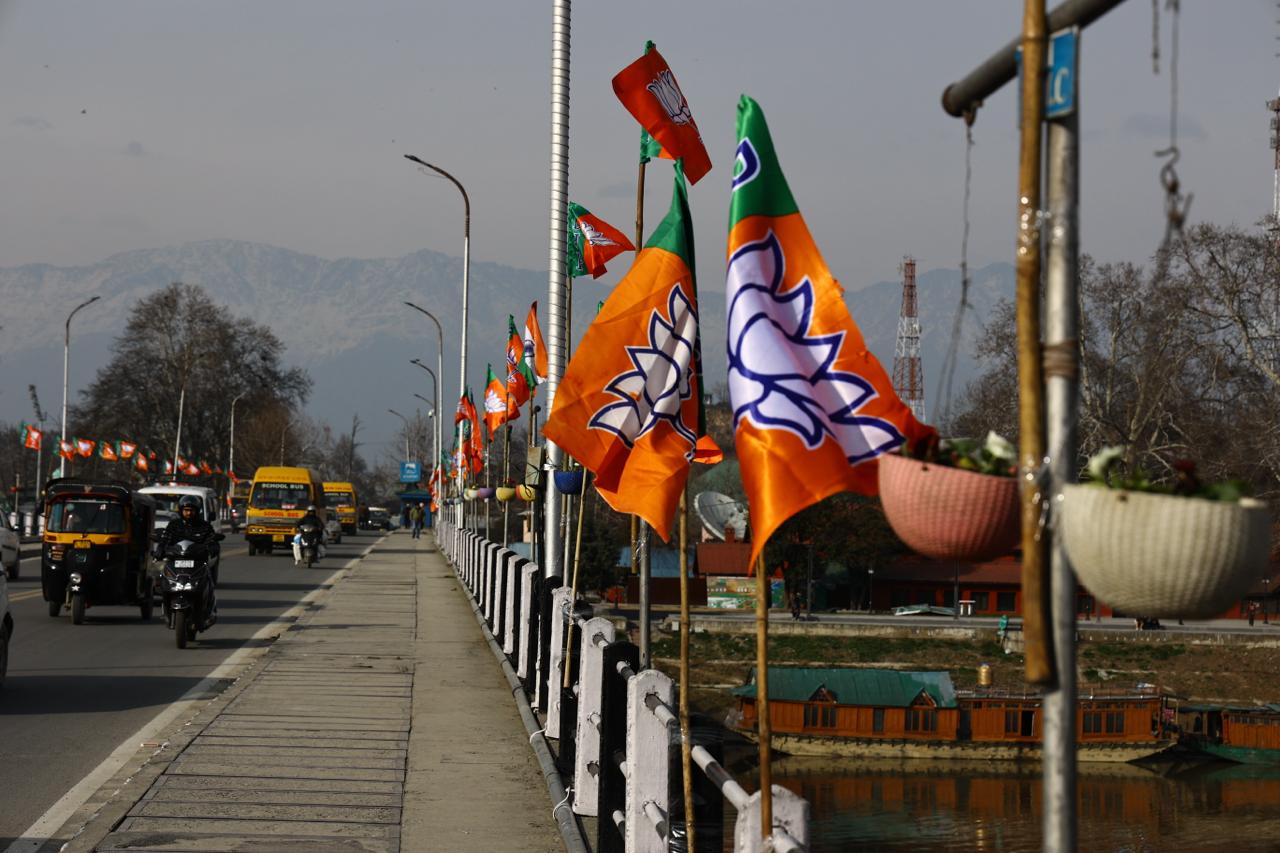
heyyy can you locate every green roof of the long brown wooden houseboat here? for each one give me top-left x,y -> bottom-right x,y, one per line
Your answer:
733,666 -> 956,708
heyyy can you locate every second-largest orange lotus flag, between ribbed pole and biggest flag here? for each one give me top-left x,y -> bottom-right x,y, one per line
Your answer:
543,167 -> 703,540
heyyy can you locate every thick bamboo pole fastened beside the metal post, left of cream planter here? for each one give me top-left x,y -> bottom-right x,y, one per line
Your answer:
1016,0 -> 1056,684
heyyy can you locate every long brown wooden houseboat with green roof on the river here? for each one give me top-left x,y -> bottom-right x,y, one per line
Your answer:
730,666 -> 1172,762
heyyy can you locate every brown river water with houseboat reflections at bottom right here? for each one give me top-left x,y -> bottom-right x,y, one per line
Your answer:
752,758 -> 1280,853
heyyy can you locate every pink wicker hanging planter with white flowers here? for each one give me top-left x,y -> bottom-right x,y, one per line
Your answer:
879,453 -> 1021,562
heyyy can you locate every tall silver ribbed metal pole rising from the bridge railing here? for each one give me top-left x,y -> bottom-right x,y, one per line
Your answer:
541,0 -> 571,578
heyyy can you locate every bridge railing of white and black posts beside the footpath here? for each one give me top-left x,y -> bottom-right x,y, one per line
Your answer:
435,520 -> 809,853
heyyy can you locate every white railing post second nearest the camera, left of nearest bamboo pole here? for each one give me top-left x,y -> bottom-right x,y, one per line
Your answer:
623,670 -> 676,853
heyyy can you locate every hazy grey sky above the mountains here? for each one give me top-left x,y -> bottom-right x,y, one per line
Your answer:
0,0 -> 1280,458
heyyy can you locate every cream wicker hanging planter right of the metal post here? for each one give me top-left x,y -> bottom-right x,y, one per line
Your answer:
1060,485 -> 1271,619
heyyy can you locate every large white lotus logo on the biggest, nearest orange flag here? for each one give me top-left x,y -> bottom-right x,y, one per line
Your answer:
728,232 -> 904,462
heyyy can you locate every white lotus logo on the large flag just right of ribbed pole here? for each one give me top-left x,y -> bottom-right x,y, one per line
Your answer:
588,284 -> 698,447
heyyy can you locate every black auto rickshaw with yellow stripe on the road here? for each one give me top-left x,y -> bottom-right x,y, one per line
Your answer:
40,478 -> 155,625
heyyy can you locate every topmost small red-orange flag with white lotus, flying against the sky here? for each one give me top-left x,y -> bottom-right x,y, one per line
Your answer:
609,41 -> 712,184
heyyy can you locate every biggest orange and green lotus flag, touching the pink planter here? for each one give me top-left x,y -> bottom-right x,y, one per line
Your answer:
726,95 -> 933,565
